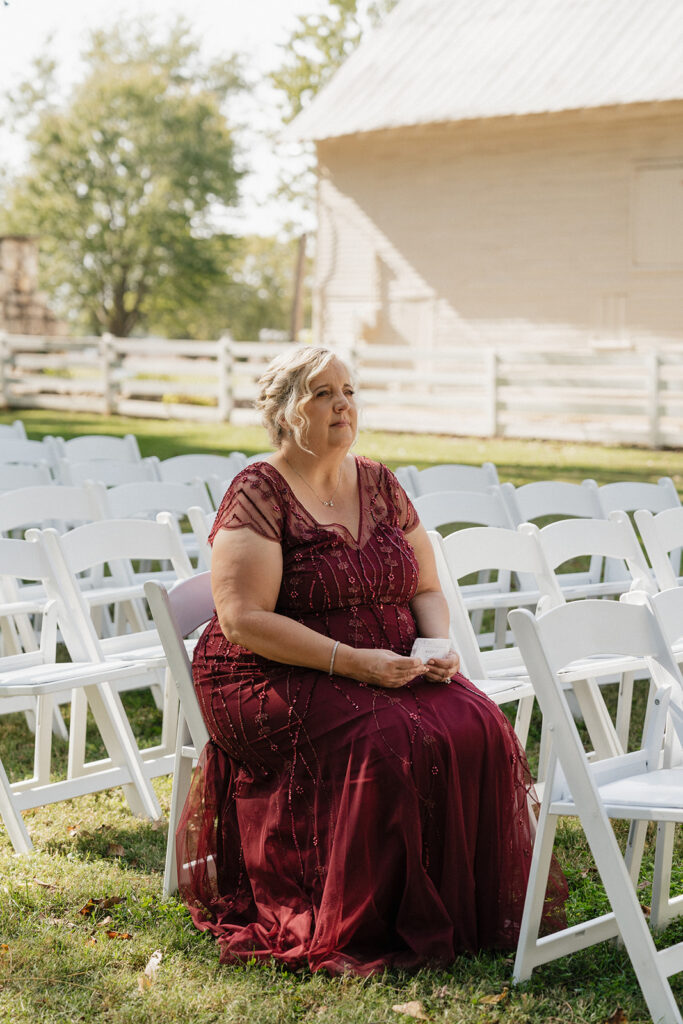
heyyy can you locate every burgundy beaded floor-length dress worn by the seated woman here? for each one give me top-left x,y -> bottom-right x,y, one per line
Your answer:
177,457 -> 563,974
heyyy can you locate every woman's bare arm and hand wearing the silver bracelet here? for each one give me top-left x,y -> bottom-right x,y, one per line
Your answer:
211,527 -> 423,687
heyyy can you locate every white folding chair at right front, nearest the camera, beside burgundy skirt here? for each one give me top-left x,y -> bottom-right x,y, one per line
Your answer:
510,600 -> 683,1024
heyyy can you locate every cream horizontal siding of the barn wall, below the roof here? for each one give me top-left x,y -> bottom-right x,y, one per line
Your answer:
315,102 -> 683,347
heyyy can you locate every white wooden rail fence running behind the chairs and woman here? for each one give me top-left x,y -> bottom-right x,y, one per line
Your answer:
0,334 -> 683,447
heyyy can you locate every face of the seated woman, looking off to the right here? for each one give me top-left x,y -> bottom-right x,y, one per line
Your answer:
301,358 -> 358,455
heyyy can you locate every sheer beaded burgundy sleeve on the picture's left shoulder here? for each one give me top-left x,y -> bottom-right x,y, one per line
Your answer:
209,463 -> 284,544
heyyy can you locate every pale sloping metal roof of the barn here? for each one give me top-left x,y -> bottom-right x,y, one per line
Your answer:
288,0 -> 683,139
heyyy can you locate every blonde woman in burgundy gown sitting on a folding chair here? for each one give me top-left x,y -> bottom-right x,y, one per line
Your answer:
178,348 -> 561,974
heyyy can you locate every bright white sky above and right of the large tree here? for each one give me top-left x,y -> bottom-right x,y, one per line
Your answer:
0,0 -> 325,234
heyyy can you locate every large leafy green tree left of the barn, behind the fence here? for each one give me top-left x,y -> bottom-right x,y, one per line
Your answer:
3,20 -> 241,337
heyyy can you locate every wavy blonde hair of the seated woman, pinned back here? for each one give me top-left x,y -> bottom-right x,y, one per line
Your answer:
256,345 -> 352,452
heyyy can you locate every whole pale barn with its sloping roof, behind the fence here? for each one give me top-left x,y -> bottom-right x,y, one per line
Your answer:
290,0 -> 683,360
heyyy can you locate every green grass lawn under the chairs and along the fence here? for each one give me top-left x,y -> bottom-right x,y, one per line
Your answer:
0,412 -> 683,1024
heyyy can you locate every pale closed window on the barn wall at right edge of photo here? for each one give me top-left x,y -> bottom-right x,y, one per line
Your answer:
632,163 -> 683,269
